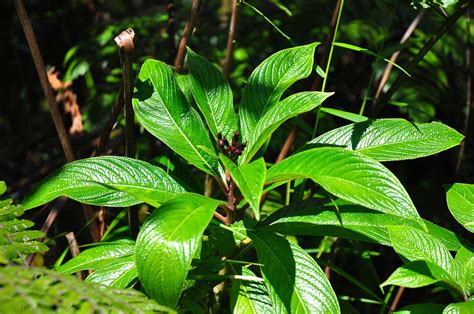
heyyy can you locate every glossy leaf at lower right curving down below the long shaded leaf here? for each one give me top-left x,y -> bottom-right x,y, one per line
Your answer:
388,226 -> 459,286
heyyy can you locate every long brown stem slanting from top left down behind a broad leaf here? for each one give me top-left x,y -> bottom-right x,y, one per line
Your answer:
15,0 -> 100,242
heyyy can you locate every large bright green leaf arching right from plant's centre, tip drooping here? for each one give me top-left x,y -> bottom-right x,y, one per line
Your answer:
267,147 -> 420,220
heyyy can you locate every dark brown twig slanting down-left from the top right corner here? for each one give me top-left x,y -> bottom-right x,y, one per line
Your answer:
373,0 -> 471,116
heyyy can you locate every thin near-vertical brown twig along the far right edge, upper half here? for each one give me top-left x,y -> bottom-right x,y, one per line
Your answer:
456,10 -> 472,179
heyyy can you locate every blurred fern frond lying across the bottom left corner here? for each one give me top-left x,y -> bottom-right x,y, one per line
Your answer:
0,266 -> 175,313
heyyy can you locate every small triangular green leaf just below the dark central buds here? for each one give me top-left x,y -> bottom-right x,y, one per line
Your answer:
221,155 -> 267,220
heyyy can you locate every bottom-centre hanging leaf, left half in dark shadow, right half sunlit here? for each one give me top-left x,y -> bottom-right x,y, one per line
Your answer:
250,231 -> 340,313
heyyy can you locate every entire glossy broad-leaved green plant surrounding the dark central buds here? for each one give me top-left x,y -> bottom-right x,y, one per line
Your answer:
9,43 -> 474,313
